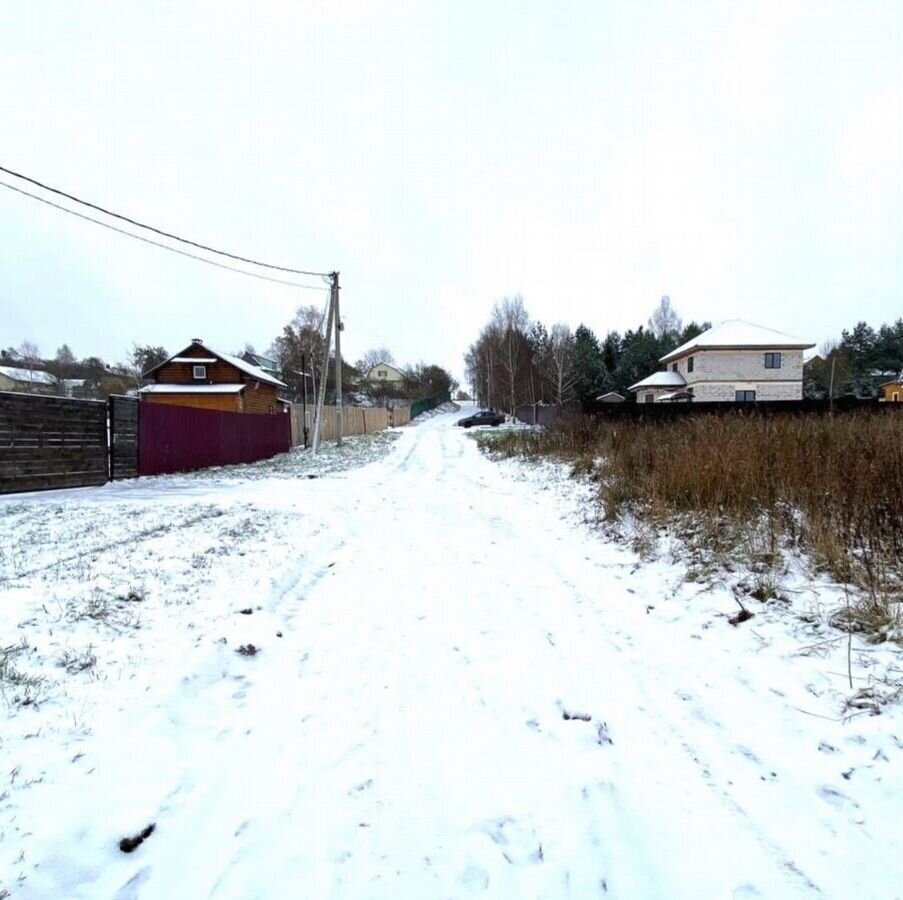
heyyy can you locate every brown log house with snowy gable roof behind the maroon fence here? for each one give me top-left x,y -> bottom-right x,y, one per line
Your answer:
140,338 -> 285,413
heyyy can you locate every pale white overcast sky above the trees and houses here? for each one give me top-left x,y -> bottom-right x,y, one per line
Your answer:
0,0 -> 903,377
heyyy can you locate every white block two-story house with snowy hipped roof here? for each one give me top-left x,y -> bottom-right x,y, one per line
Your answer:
630,319 -> 815,403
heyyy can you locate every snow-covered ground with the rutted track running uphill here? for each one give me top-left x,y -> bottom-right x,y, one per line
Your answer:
0,409 -> 903,900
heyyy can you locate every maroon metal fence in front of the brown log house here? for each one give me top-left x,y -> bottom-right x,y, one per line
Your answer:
138,401 -> 291,475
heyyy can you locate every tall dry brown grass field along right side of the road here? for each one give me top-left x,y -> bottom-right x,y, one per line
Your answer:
492,411 -> 903,631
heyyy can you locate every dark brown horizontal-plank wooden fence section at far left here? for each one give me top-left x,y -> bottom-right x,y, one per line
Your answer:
0,392 -> 108,494
